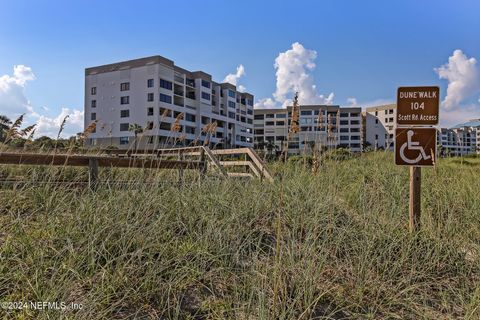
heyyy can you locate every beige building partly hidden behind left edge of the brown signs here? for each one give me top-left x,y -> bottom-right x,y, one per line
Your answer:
365,104 -> 397,150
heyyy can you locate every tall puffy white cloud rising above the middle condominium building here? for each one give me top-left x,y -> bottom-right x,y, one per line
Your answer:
255,42 -> 334,108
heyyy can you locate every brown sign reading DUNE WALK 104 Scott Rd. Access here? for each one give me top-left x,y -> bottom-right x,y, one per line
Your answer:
397,87 -> 440,125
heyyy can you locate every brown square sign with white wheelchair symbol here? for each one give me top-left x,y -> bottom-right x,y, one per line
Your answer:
395,127 -> 437,166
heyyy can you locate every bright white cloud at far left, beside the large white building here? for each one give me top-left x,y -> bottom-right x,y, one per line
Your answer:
0,65 -> 83,137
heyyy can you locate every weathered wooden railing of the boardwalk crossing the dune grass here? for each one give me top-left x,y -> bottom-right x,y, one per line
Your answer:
0,146 -> 273,188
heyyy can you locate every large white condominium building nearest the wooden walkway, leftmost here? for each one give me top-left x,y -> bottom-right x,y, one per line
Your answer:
85,56 -> 254,149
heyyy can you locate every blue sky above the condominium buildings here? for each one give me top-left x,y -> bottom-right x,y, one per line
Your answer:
0,0 -> 480,136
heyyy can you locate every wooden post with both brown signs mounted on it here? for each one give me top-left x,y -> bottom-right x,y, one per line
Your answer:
395,87 -> 440,232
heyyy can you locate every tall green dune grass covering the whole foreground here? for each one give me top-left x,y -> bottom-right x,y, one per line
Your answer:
0,152 -> 480,320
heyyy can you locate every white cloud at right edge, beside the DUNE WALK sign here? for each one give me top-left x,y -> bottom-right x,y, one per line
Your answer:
434,49 -> 480,109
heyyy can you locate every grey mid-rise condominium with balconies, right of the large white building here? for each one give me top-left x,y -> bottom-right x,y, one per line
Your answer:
253,105 -> 362,154
